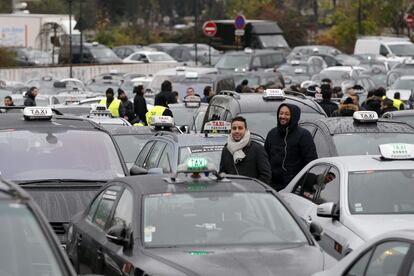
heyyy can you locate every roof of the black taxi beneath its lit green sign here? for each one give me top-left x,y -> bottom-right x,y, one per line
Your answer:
113,174 -> 268,195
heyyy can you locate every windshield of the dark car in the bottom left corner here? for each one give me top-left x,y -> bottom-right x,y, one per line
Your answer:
0,202 -> 66,276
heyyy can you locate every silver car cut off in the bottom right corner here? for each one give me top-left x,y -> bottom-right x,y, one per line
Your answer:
313,229 -> 414,276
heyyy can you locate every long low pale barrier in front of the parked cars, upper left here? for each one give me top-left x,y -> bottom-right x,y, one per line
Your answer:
0,63 -> 179,82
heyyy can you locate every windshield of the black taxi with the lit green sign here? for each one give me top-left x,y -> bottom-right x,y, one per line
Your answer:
142,192 -> 307,247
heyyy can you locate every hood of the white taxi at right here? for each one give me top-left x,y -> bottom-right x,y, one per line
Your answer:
344,214 -> 414,241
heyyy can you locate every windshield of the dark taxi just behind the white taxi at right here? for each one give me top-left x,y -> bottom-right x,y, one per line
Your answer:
333,133 -> 414,156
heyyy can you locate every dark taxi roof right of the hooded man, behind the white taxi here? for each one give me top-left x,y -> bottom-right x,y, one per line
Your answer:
302,117 -> 414,135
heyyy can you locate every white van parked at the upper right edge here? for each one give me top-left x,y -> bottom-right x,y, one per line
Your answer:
354,36 -> 414,58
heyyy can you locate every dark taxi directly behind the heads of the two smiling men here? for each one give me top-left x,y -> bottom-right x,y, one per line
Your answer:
202,91 -> 326,138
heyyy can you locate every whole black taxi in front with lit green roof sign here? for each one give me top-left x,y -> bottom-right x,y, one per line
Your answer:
67,158 -> 325,276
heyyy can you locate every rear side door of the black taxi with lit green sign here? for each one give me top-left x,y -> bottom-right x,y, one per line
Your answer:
76,186 -> 122,274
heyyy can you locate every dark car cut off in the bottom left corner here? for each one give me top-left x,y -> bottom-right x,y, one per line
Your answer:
0,178 -> 76,276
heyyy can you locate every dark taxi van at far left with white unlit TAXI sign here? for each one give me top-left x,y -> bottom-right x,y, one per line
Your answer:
0,107 -> 128,243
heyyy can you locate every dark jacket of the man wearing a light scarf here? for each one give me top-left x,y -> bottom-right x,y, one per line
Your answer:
220,141 -> 272,184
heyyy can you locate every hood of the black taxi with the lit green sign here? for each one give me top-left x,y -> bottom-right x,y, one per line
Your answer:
146,244 -> 324,276
